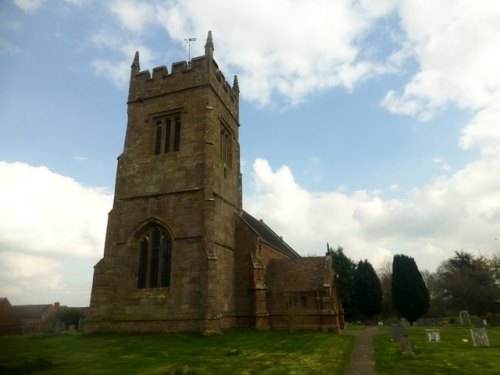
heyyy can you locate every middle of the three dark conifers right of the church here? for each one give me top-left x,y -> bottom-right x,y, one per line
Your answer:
354,259 -> 382,316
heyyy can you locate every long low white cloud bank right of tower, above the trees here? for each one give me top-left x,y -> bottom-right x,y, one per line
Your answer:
244,159 -> 500,269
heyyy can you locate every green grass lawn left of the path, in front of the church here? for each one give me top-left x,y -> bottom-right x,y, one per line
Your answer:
0,330 -> 354,375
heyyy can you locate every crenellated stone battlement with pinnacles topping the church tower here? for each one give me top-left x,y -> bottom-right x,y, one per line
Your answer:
128,32 -> 239,116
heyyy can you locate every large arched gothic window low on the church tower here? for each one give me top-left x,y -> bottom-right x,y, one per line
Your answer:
137,225 -> 172,288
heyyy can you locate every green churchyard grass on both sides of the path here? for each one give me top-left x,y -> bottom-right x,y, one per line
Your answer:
0,322 -> 500,375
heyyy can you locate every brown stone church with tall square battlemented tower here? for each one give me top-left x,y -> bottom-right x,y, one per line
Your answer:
84,32 -> 343,335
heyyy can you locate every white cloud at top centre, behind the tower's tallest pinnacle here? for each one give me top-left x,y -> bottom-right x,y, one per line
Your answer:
158,0 -> 395,104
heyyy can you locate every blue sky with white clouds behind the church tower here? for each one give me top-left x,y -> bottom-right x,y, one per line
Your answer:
0,0 -> 500,306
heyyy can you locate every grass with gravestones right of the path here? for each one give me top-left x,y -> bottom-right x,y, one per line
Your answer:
373,326 -> 500,375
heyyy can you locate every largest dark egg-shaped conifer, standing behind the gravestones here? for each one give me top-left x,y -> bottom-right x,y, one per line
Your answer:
392,254 -> 429,322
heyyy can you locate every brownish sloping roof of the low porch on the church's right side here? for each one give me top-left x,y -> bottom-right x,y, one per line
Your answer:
266,257 -> 325,292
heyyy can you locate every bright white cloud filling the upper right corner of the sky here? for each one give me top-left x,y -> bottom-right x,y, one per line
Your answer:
383,0 -> 500,121
